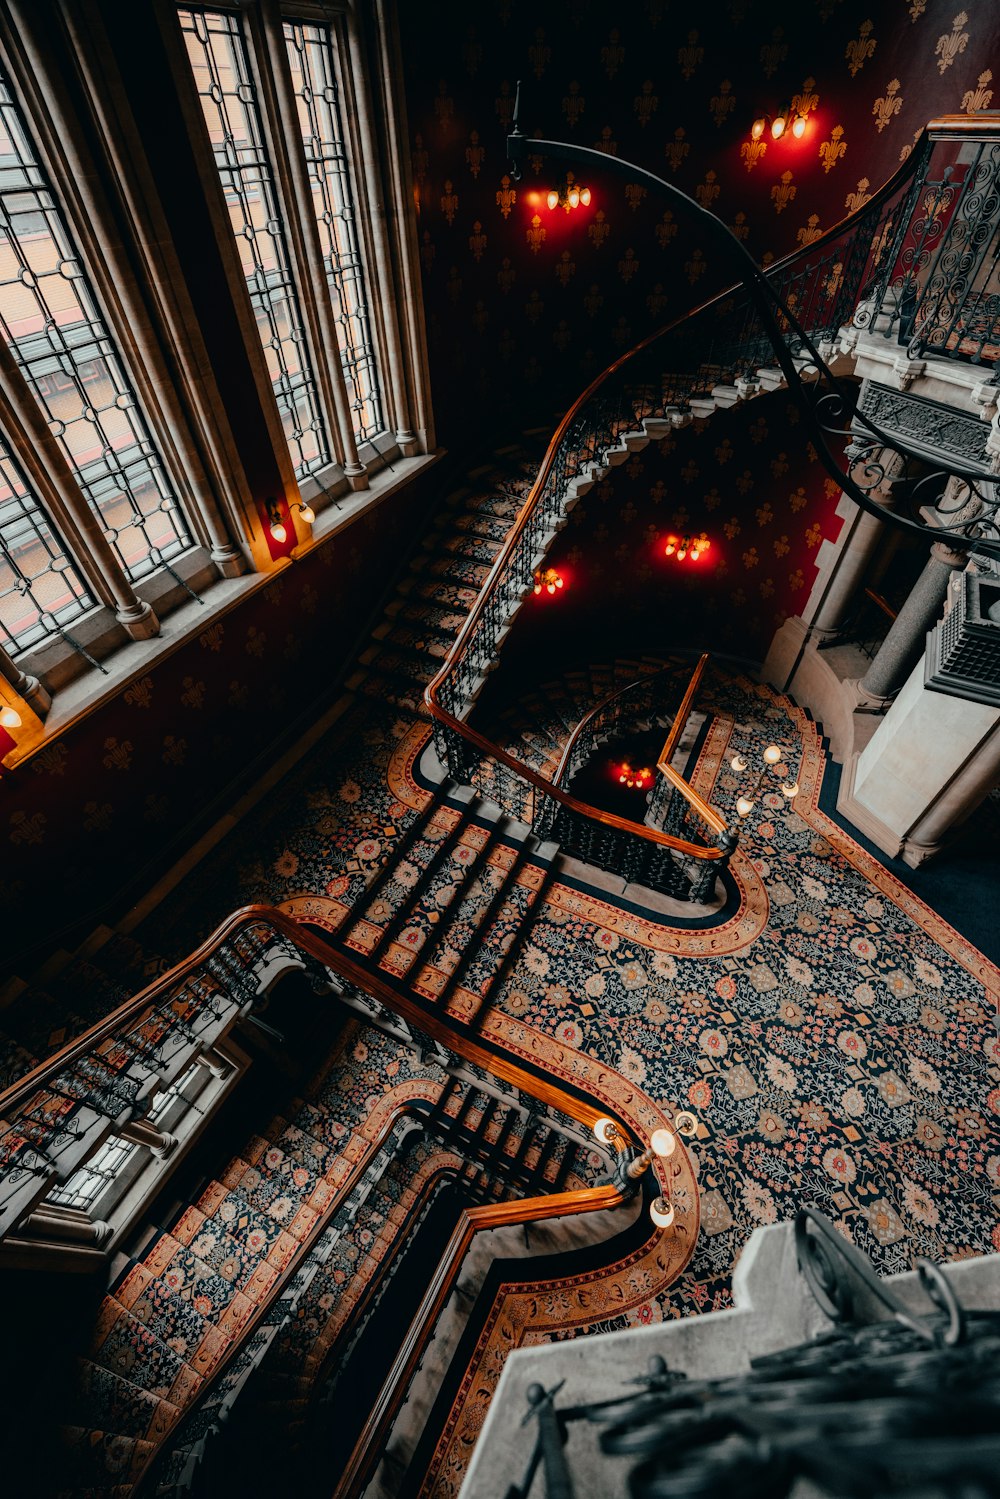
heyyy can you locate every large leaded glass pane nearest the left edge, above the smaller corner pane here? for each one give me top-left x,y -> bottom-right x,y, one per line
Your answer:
0,76 -> 192,584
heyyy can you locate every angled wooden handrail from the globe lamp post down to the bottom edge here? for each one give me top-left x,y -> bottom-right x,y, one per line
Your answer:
331,1187 -> 624,1499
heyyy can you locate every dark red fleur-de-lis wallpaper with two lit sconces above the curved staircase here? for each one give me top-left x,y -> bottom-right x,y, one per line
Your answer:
400,0 -> 1000,442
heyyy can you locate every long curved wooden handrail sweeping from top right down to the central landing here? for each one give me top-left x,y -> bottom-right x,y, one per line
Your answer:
424,125 -> 953,859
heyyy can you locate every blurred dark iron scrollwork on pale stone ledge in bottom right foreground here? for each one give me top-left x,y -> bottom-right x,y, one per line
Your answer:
505,1208 -> 1000,1499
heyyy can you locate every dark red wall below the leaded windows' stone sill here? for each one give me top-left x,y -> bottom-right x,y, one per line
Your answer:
0,485 -> 435,959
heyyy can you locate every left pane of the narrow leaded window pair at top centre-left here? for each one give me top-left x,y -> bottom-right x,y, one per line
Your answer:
180,10 -> 330,478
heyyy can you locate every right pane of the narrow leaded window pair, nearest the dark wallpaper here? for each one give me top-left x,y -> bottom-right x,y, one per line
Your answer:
283,21 -> 385,442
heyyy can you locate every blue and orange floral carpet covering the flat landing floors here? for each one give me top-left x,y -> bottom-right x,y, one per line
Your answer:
132,485 -> 1000,1493
